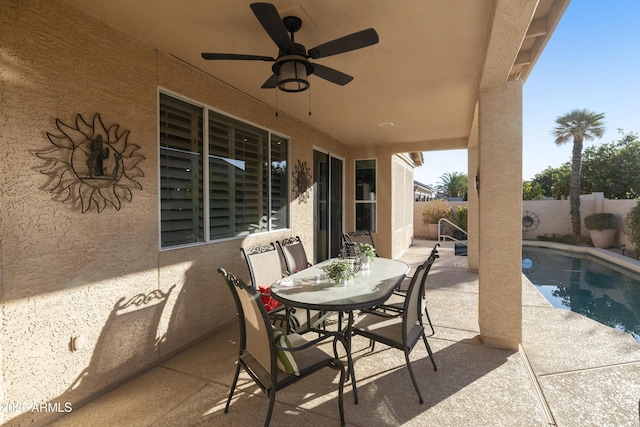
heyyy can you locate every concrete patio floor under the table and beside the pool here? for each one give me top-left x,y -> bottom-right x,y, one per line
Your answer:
54,240 -> 640,427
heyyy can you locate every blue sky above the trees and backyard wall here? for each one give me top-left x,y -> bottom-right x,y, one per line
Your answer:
414,0 -> 640,185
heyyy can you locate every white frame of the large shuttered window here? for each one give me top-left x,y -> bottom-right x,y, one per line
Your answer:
156,87 -> 291,251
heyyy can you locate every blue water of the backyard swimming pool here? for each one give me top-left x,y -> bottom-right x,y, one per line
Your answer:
522,247 -> 640,344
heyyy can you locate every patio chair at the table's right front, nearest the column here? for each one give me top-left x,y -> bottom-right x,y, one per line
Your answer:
353,265 -> 438,403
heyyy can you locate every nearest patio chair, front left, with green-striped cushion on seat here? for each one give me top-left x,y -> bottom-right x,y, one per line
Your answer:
218,268 -> 345,427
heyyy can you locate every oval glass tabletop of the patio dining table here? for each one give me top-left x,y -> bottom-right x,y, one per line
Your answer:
271,257 -> 409,312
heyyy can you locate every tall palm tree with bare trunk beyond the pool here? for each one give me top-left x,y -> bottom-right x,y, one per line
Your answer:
551,108 -> 604,237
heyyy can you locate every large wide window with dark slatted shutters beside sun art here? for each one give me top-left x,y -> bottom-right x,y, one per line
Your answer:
160,93 -> 289,247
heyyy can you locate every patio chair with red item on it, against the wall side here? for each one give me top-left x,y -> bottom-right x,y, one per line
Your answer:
240,243 -> 318,331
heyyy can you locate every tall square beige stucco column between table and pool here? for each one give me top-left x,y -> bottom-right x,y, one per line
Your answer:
478,81 -> 522,349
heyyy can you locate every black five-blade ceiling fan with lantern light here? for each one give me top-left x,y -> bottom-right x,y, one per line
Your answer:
202,3 -> 379,92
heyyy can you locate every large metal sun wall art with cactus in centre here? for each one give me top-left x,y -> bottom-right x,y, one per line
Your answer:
36,113 -> 144,213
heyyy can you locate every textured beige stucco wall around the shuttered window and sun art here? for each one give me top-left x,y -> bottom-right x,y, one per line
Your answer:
0,0 -> 346,425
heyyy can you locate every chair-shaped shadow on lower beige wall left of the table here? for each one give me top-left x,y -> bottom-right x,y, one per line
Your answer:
3,247 -> 235,427
